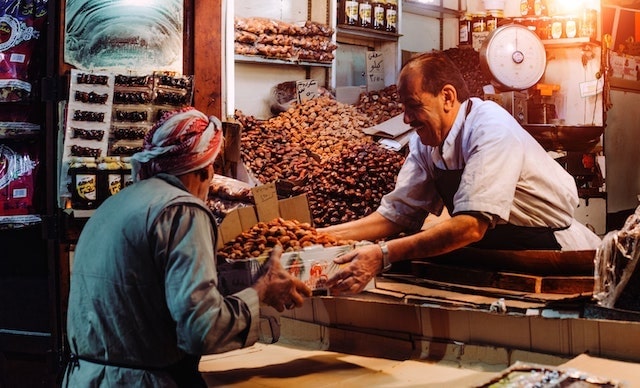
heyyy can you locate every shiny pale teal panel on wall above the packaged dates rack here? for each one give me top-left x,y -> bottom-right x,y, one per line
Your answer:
64,0 -> 184,72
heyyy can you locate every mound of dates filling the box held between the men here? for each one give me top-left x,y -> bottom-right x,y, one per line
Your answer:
217,218 -> 353,261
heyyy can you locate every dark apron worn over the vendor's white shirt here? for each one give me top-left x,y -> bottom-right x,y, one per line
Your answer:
435,100 -> 562,250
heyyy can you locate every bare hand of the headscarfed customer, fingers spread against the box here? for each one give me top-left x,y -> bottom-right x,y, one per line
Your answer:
253,245 -> 311,312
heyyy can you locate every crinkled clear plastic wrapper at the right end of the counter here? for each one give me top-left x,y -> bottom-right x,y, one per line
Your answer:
594,207 -> 640,308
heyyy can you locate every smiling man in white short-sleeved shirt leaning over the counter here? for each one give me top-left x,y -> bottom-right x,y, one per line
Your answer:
322,52 -> 600,294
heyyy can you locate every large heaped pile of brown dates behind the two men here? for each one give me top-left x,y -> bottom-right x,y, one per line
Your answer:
236,94 -> 405,227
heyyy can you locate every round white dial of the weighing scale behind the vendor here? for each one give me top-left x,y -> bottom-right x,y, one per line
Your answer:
480,24 -> 547,91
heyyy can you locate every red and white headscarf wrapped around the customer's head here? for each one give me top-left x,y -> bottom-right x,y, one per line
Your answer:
131,107 -> 222,180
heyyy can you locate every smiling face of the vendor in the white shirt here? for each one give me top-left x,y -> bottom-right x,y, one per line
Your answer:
399,69 -> 449,146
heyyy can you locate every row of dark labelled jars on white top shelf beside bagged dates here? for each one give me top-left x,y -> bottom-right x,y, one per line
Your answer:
338,0 -> 398,33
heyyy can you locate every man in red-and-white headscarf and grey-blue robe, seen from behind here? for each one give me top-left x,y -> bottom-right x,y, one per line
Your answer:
63,108 -> 311,387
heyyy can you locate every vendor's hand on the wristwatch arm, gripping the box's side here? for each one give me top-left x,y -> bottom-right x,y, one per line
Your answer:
327,244 -> 382,295
